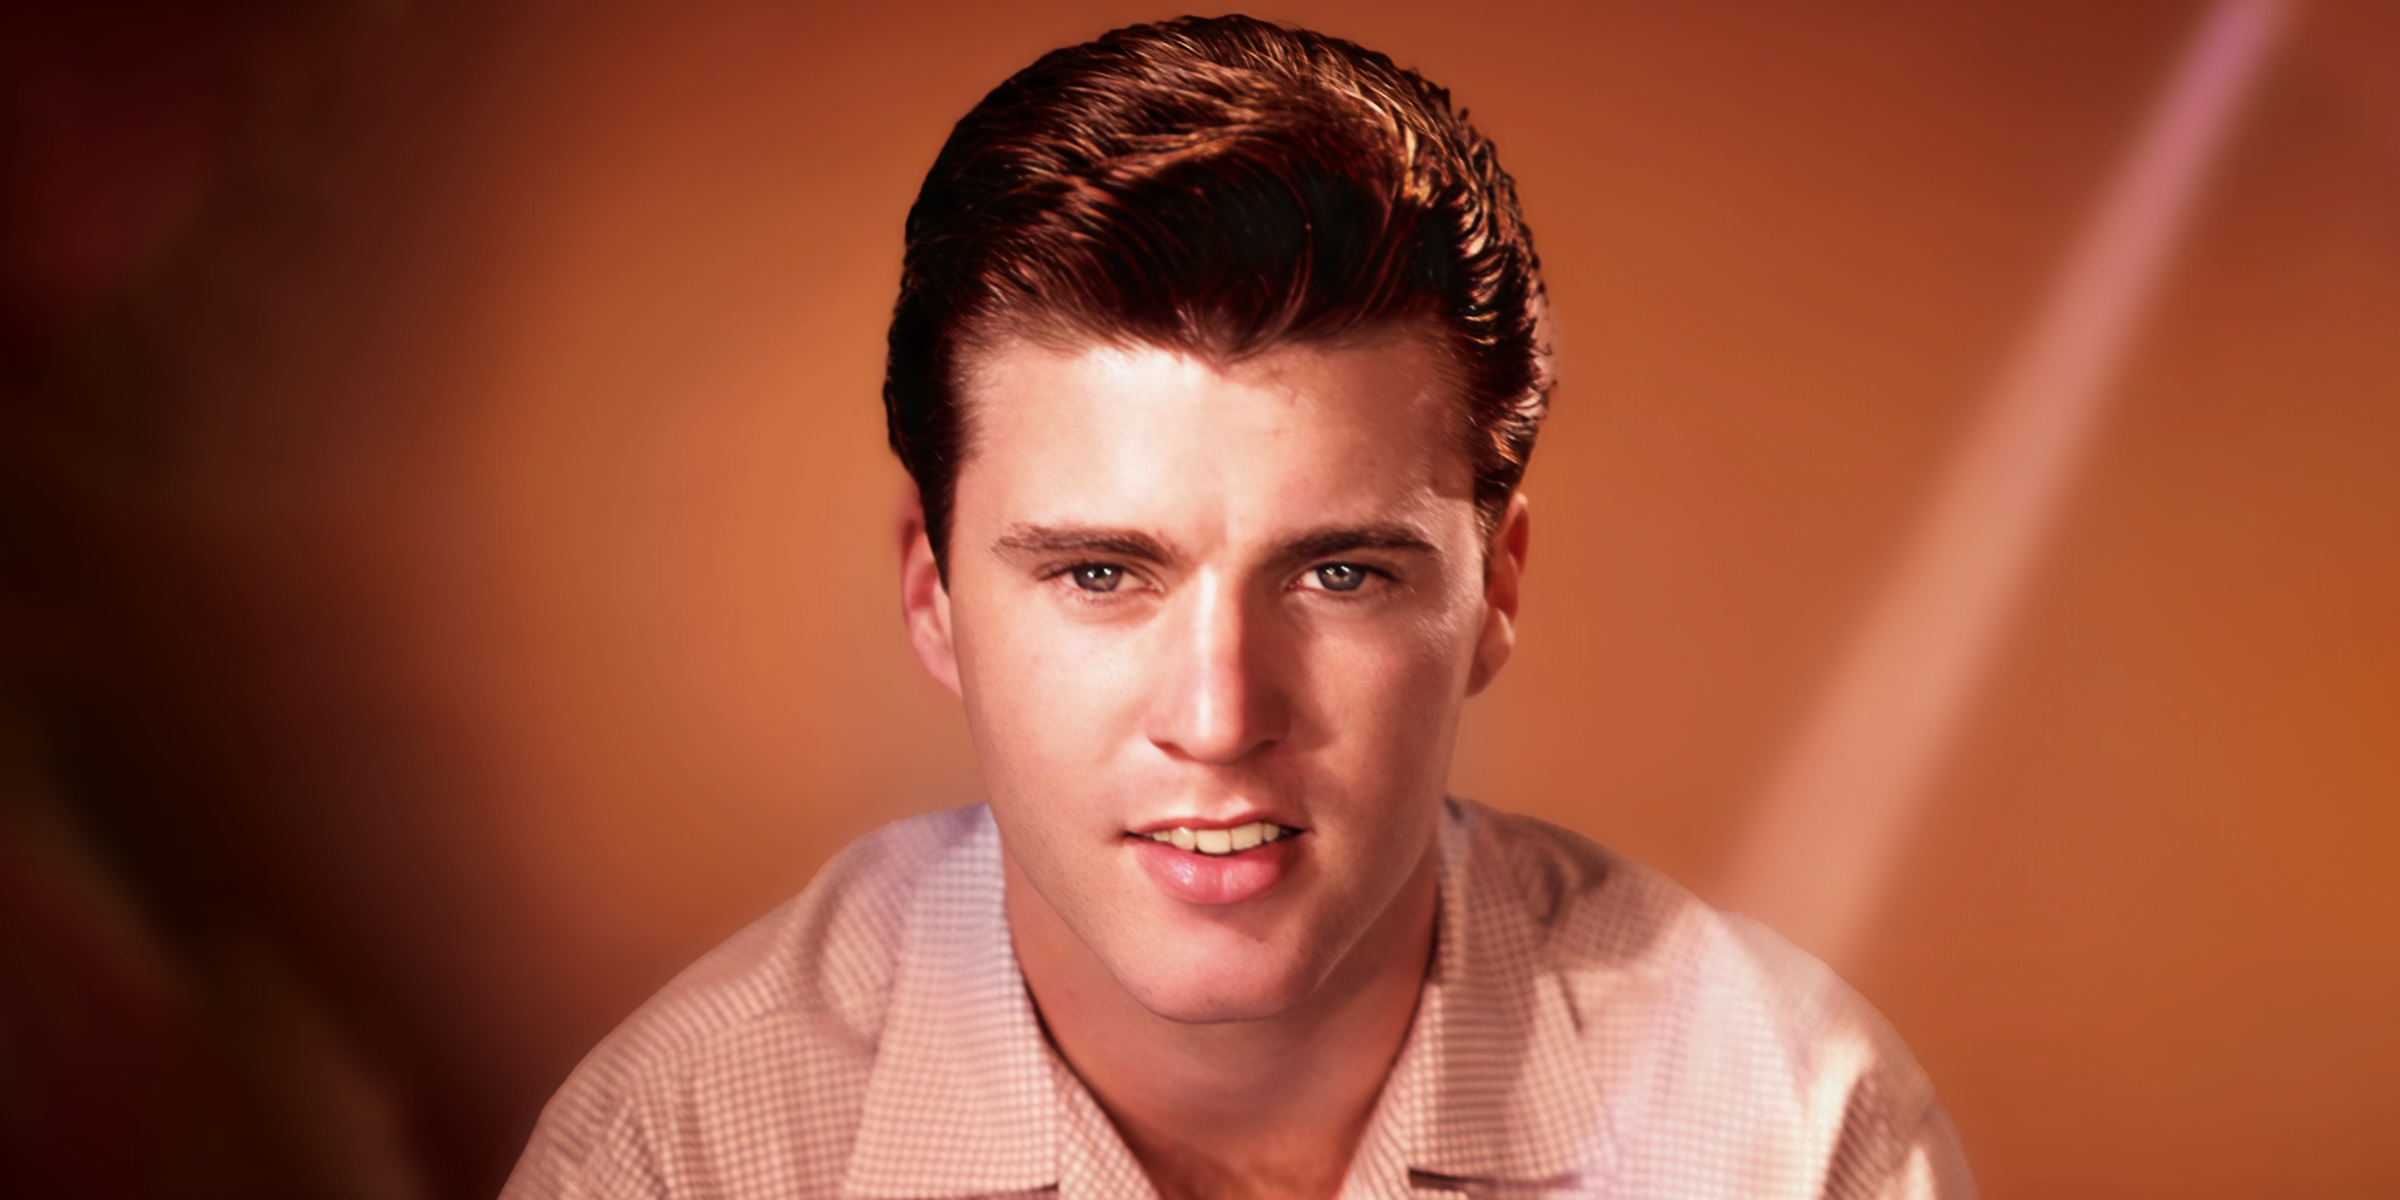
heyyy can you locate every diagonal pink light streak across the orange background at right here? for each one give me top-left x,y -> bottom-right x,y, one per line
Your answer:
1726,0 -> 2292,962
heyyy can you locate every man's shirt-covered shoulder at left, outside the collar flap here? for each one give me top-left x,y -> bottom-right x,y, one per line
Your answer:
504,806 -> 989,1198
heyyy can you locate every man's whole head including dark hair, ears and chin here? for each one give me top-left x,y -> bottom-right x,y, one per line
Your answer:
886,17 -> 1548,1020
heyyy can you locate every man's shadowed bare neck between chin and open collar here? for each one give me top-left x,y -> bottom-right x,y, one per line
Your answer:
1008,847 -> 1438,1200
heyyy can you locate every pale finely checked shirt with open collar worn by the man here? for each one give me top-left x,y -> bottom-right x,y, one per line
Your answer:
504,802 -> 1975,1200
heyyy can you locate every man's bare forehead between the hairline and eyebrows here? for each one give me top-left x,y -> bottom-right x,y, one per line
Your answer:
955,329 -> 1474,530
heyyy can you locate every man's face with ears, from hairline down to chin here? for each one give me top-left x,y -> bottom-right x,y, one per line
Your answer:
910,329 -> 1524,1020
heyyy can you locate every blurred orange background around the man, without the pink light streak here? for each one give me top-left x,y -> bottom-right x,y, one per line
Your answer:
0,0 -> 2400,1198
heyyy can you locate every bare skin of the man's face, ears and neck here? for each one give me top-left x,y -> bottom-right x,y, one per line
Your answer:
902,326 -> 1529,1200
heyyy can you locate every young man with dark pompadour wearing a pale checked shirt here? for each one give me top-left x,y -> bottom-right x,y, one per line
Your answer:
509,17 -> 1973,1200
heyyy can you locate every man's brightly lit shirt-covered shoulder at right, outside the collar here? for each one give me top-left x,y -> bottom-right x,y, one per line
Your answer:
1454,804 -> 1973,1195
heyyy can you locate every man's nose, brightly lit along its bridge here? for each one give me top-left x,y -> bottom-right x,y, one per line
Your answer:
1145,576 -> 1289,763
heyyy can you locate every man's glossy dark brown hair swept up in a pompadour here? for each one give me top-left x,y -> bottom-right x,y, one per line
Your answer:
883,17 -> 1550,574
